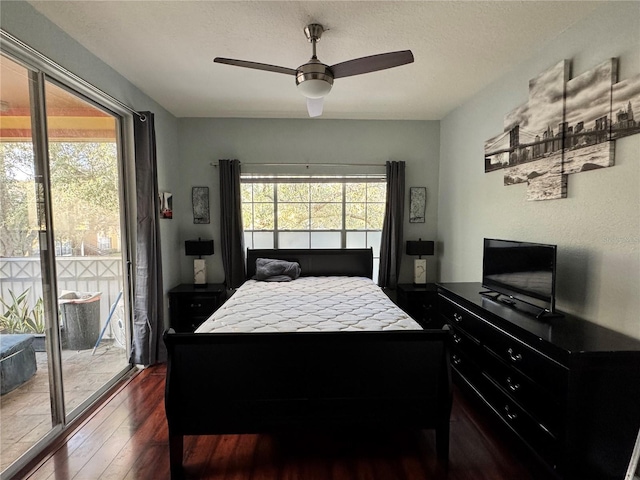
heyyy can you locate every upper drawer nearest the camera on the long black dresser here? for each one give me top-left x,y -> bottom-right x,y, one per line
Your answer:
482,327 -> 568,397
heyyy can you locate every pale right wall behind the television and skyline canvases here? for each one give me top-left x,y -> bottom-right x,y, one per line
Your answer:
438,2 -> 640,338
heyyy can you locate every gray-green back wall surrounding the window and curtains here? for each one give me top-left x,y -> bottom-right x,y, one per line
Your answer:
171,118 -> 440,282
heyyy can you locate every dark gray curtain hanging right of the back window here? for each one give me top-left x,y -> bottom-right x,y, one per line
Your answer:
378,162 -> 405,288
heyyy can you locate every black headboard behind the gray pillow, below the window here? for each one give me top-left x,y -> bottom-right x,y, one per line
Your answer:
247,248 -> 373,278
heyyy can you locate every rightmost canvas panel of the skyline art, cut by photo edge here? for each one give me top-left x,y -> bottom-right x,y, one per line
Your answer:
611,75 -> 640,140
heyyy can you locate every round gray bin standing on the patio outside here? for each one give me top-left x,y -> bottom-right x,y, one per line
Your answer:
58,291 -> 101,350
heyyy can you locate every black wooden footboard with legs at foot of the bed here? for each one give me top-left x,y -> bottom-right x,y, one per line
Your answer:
164,330 -> 452,478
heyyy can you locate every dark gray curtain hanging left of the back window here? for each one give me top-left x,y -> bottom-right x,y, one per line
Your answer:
218,160 -> 246,288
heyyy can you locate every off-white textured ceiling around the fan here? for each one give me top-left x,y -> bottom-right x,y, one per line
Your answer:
30,0 -> 606,120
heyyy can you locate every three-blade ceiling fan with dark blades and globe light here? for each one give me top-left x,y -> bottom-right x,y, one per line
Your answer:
213,23 -> 413,117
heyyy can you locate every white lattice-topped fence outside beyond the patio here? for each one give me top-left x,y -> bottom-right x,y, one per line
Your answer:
0,257 -> 123,337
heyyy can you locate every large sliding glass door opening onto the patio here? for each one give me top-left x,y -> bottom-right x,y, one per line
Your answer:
0,47 -> 130,474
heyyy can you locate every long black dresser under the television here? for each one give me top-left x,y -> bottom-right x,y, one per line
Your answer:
438,283 -> 640,480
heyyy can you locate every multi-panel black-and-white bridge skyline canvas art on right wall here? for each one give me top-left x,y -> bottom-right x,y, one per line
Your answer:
484,58 -> 640,200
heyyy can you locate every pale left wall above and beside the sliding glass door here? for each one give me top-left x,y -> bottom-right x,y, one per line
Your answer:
0,1 -> 179,326
